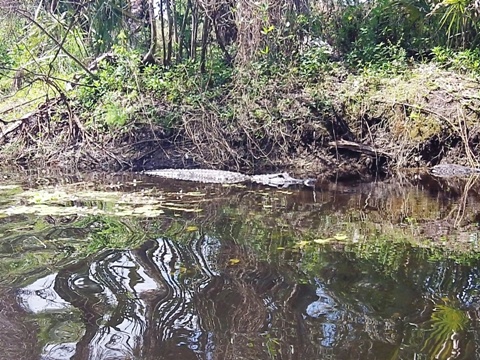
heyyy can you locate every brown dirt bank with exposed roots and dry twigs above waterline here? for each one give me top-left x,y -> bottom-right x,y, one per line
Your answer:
0,65 -> 480,178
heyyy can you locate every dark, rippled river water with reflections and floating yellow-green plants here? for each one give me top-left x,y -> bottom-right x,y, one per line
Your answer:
0,171 -> 480,360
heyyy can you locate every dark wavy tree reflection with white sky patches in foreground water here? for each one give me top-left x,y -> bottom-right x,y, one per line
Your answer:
11,235 -> 480,359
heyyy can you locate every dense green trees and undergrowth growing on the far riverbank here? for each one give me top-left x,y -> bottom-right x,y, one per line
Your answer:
0,0 -> 480,171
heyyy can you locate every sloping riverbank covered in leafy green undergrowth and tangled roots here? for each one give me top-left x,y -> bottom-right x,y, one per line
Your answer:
0,49 -> 480,178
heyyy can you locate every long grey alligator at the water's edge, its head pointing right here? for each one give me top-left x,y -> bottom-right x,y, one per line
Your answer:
143,169 -> 316,188
